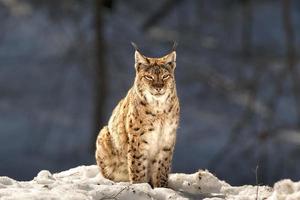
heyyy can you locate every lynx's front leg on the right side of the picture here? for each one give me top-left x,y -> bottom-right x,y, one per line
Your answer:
151,147 -> 174,187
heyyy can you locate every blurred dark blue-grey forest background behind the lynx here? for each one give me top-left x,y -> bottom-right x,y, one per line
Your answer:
0,0 -> 300,184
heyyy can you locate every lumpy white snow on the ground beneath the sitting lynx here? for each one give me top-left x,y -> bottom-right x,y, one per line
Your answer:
0,165 -> 300,200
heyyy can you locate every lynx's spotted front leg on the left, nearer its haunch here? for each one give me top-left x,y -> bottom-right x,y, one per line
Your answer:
127,135 -> 148,183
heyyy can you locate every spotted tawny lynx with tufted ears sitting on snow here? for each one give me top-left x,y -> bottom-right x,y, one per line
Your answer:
95,44 -> 179,187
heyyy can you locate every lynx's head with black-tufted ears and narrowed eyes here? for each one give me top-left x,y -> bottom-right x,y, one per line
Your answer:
135,44 -> 176,99
